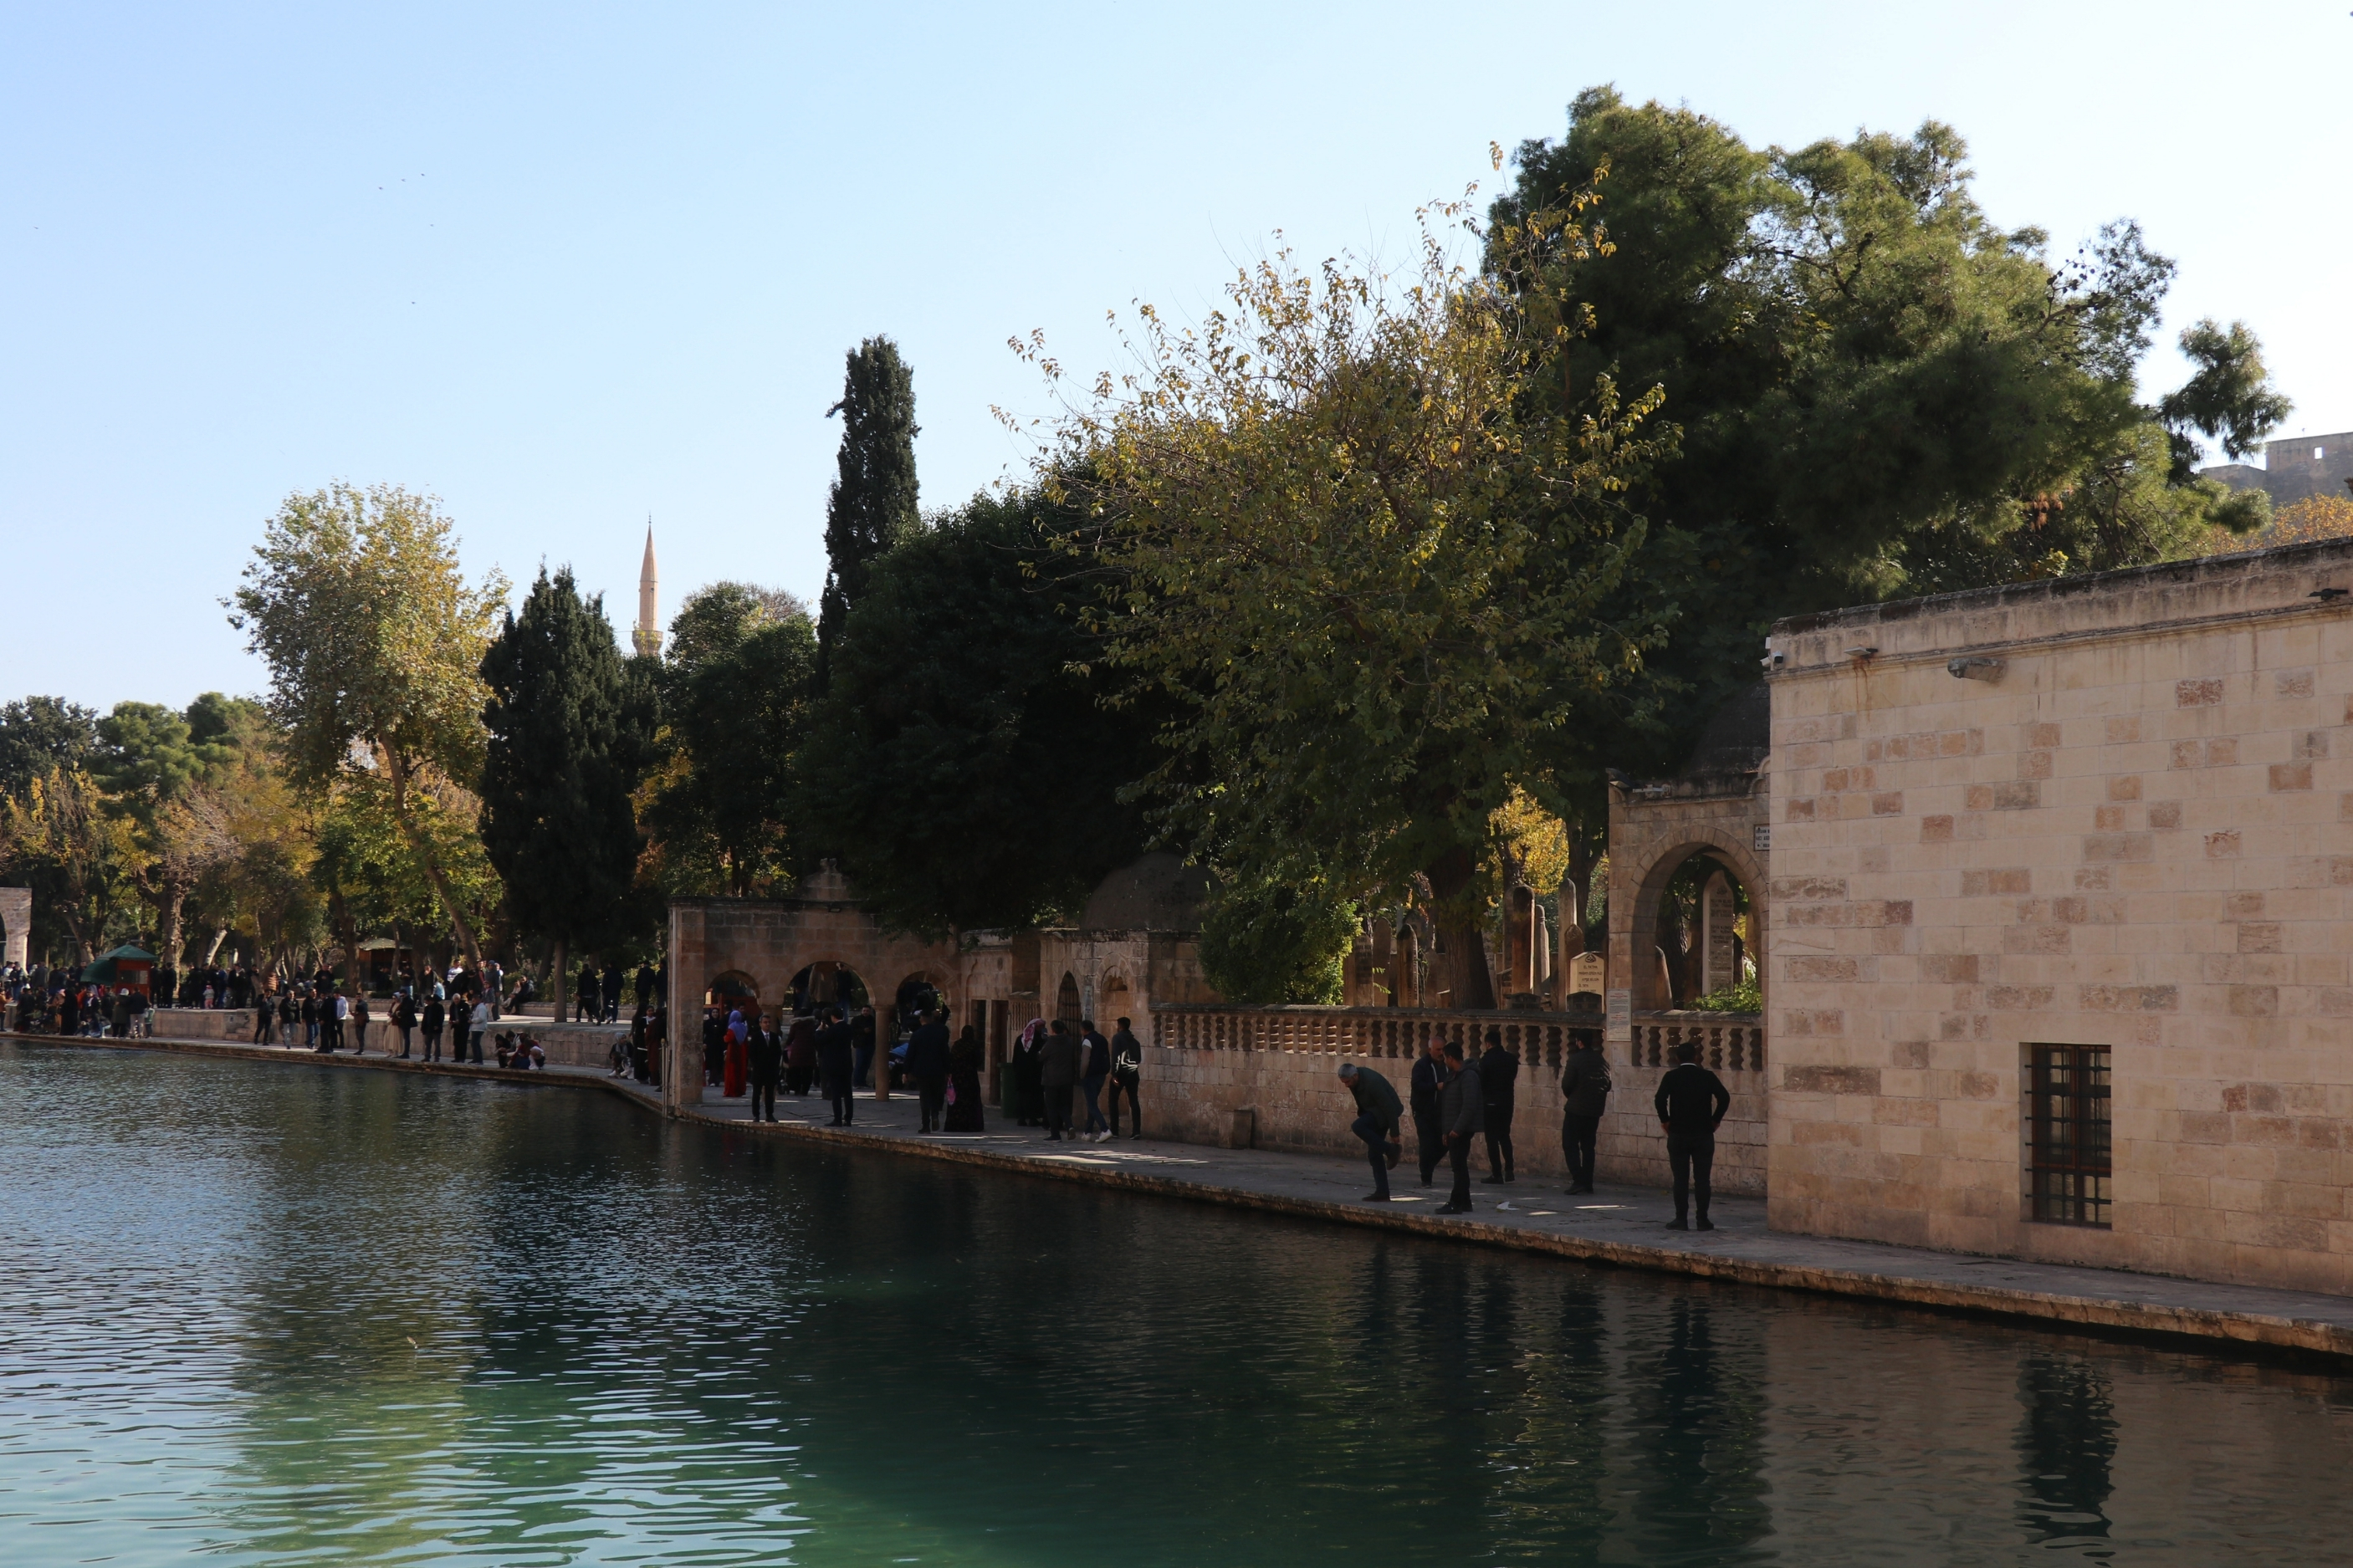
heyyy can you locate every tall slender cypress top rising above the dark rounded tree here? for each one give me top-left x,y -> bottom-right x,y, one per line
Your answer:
816,339 -> 920,691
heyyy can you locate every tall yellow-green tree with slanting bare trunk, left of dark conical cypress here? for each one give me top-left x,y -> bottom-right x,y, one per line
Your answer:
228,484 -> 506,968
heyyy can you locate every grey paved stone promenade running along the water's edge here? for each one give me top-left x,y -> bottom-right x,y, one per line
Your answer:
7,1037 -> 2353,1359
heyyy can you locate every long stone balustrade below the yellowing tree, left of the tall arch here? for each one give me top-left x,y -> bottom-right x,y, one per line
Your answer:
1153,1002 -> 1603,1067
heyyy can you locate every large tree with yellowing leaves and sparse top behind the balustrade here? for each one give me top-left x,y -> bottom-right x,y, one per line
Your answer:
1040,205 -> 1650,1006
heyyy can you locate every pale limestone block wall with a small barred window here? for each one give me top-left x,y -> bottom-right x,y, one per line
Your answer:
1767,541 -> 2353,1290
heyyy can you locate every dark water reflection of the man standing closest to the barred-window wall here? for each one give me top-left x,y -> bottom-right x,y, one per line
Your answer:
1635,1293 -> 1772,1563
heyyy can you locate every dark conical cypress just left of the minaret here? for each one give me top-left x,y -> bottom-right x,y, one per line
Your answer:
483,566 -> 642,1018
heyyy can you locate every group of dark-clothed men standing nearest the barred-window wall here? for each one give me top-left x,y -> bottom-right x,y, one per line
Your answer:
1339,1027 -> 1732,1229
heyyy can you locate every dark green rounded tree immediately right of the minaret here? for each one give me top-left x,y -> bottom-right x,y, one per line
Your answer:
637,583 -> 816,896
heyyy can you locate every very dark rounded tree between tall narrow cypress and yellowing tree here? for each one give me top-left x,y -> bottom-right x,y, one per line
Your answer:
795,492 -> 1155,936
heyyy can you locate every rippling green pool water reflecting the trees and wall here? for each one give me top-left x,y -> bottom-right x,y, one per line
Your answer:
0,1044 -> 2353,1565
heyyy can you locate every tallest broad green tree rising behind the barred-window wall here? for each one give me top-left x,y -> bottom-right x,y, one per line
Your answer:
1490,87 -> 2275,764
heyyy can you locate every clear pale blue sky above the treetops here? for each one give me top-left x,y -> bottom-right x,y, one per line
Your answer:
0,0 -> 2353,710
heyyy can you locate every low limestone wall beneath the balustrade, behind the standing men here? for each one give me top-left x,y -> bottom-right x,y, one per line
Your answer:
1137,1046 -> 1767,1197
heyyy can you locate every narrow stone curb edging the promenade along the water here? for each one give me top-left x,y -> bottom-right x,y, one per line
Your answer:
18,1034 -> 2353,1361
